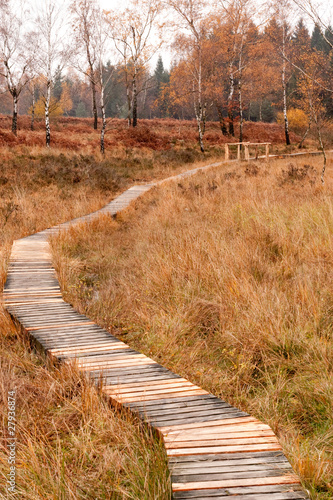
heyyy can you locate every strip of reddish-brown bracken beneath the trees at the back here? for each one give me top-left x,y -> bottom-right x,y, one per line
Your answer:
0,115 -> 304,154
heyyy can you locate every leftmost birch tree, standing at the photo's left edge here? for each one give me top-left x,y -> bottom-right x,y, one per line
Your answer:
0,1 -> 36,135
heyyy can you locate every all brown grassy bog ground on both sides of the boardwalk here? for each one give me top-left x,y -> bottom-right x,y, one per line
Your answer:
1,116 -> 332,499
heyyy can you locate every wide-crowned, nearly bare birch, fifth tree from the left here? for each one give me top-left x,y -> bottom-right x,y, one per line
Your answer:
107,0 -> 161,127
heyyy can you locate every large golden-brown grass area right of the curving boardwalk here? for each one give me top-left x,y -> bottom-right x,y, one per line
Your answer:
52,158 -> 333,500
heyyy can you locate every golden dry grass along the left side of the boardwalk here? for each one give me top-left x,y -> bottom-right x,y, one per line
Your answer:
0,145 -> 217,500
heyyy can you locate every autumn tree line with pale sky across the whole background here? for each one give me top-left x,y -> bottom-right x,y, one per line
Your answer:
0,0 -> 333,152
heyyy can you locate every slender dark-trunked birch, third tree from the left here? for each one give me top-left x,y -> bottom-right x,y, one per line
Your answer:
70,0 -> 100,130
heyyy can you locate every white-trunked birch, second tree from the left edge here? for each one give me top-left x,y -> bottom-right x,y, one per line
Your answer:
35,0 -> 71,147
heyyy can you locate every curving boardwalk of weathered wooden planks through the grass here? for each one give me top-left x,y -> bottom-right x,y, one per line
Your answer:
4,164 -> 308,500
